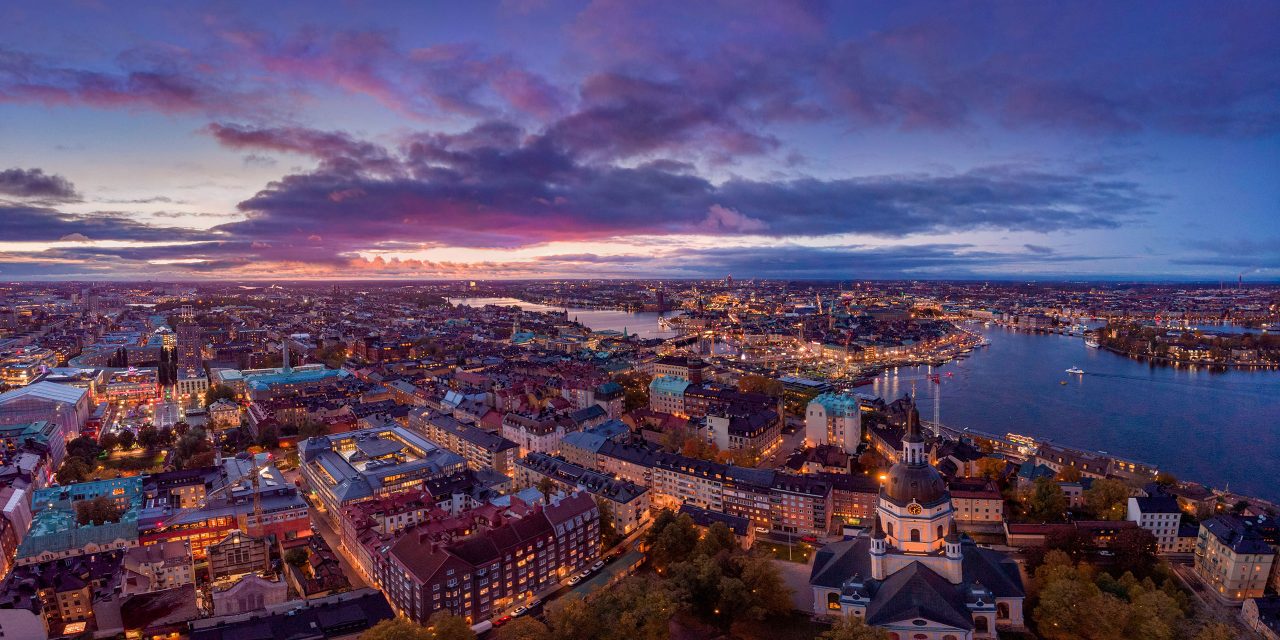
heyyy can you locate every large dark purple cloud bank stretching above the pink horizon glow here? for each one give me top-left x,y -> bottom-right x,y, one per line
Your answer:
202,123 -> 1156,252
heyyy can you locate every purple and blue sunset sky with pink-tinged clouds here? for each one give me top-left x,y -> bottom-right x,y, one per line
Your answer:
0,0 -> 1280,282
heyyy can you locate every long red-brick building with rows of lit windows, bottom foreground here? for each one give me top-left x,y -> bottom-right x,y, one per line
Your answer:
379,493 -> 600,625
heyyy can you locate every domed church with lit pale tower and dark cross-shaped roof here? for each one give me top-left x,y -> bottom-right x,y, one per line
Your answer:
809,420 -> 1024,640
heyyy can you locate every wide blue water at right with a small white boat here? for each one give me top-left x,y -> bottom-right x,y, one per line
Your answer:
875,328 -> 1280,500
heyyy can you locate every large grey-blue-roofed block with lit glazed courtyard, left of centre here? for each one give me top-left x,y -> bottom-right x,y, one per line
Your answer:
300,426 -> 466,518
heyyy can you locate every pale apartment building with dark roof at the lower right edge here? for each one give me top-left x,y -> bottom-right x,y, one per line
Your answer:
1196,516 -> 1276,600
